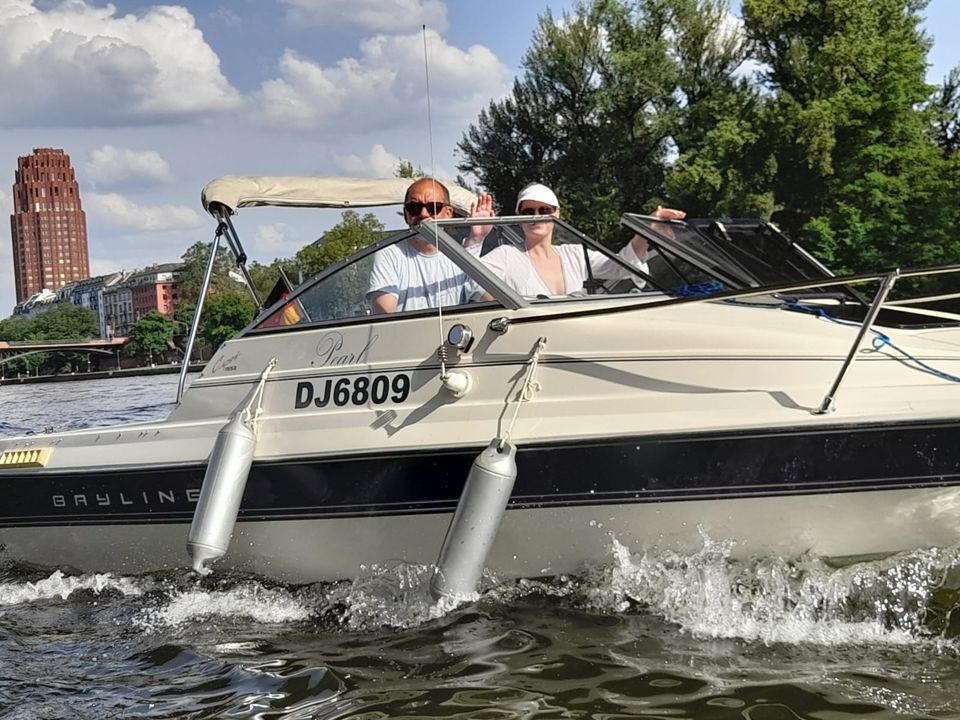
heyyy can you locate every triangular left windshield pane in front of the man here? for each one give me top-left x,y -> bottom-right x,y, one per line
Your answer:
247,229 -> 510,332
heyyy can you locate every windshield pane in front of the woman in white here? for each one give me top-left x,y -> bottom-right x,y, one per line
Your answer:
420,215 -> 663,307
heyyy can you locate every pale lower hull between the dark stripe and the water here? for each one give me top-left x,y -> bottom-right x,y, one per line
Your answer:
0,480 -> 960,583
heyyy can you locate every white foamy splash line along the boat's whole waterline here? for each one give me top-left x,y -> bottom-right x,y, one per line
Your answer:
0,533 -> 960,646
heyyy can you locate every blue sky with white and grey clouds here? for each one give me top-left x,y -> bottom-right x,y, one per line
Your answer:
0,0 -> 960,318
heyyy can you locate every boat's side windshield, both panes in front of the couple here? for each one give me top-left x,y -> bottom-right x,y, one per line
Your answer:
251,216 -> 659,330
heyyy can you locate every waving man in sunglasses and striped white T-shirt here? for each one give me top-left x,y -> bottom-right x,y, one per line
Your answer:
367,178 -> 493,313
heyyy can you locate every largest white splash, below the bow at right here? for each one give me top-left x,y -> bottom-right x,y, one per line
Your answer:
560,534 -> 960,645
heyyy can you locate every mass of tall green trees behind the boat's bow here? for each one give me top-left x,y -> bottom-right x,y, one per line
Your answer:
458,0 -> 960,271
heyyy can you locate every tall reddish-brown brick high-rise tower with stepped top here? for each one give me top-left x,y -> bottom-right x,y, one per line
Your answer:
10,148 -> 90,302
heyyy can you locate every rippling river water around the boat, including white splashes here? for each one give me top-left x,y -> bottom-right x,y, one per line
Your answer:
0,375 -> 960,720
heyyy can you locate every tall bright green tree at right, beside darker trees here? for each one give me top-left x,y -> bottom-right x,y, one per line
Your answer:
743,0 -> 944,270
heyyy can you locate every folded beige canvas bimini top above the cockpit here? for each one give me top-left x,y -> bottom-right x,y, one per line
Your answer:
200,176 -> 476,217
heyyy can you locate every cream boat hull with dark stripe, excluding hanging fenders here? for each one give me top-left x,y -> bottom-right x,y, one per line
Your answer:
0,302 -> 960,582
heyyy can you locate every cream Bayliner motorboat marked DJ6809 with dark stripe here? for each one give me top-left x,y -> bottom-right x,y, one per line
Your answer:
0,177 -> 960,590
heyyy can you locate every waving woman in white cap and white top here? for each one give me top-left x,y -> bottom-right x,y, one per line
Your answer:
482,183 -> 686,297
